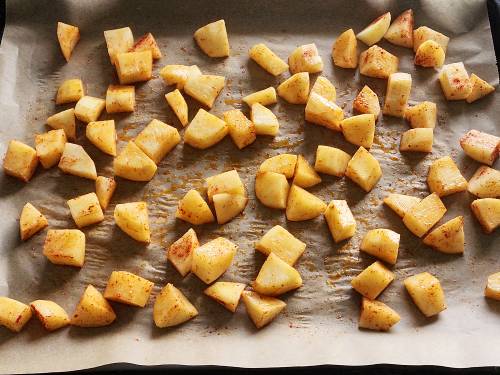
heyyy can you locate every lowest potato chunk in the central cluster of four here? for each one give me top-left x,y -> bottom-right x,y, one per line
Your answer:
286,184 -> 326,221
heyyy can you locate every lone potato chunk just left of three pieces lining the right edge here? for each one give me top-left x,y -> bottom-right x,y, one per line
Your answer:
427,156 -> 467,197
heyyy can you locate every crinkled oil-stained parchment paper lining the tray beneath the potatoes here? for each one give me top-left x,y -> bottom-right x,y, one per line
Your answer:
0,0 -> 500,373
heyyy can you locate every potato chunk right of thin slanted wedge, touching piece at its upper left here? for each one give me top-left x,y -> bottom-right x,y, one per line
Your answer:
184,74 -> 226,108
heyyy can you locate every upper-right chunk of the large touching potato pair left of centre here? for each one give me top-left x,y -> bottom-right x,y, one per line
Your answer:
134,119 -> 181,164
